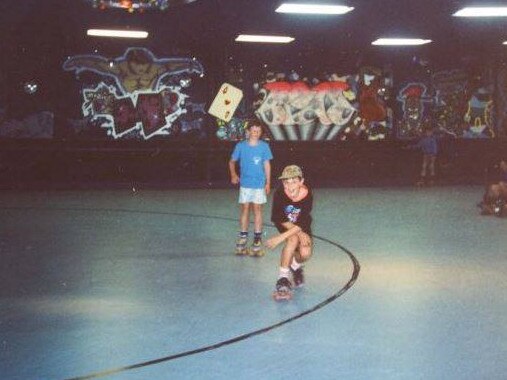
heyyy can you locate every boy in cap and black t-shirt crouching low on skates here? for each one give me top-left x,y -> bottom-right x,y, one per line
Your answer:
265,165 -> 313,300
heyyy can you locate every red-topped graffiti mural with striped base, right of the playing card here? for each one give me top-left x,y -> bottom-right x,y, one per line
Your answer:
217,68 -> 391,141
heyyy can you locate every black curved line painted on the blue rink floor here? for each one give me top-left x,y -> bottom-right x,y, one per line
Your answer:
0,207 -> 361,380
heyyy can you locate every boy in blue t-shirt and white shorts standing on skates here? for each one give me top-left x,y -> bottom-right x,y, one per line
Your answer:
229,121 -> 273,256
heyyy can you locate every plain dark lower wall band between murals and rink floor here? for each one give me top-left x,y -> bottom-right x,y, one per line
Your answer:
0,140 -> 507,189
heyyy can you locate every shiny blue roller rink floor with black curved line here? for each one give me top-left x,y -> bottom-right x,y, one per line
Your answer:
0,186 -> 507,380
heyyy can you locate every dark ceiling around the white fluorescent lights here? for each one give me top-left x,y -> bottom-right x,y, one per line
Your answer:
0,0 -> 507,59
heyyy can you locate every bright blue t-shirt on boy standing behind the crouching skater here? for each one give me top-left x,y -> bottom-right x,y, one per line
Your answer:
231,140 -> 273,189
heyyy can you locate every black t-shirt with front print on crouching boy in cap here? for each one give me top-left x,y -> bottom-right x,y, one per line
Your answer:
271,185 -> 313,235
